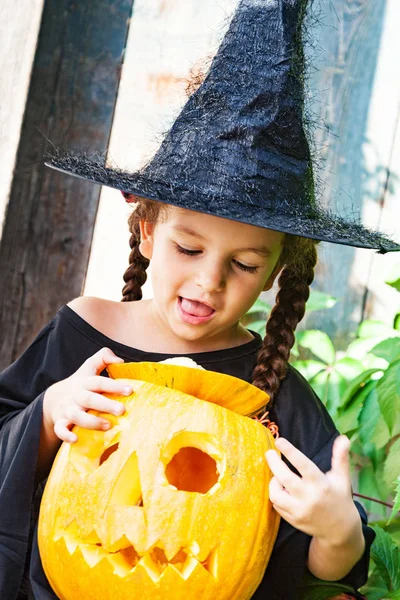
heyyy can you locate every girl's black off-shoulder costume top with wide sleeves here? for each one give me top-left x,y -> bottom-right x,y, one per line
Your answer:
0,306 -> 375,600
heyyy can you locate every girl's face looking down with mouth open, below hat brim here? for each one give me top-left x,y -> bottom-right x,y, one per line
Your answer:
140,206 -> 284,352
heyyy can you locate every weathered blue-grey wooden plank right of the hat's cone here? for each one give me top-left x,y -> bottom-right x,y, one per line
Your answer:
307,0 -> 400,347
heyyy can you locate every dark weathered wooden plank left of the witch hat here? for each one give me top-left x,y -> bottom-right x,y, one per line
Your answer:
0,0 -> 133,367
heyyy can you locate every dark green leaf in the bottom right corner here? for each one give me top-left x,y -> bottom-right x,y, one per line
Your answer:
371,526 -> 400,591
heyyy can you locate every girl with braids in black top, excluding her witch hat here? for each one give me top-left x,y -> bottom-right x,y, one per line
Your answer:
0,199 -> 373,600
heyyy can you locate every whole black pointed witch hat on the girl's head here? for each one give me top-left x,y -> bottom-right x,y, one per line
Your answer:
47,0 -> 400,253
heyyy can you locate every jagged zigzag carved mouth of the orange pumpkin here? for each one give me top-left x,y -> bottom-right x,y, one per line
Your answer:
62,536 -> 218,583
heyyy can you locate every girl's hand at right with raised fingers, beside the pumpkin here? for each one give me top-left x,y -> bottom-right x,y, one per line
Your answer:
266,435 -> 360,544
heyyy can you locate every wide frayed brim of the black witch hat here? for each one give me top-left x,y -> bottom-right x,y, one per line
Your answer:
46,153 -> 400,254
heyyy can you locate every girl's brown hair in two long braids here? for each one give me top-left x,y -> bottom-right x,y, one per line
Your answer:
122,194 -> 318,408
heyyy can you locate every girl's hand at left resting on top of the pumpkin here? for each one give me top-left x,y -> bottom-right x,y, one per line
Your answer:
43,348 -> 132,443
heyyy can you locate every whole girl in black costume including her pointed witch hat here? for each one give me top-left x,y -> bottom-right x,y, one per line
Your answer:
0,0 -> 399,600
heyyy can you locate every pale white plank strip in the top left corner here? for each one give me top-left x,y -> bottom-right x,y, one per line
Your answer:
0,0 -> 44,238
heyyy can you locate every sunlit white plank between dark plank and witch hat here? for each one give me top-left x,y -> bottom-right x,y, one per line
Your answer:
84,0 -> 238,301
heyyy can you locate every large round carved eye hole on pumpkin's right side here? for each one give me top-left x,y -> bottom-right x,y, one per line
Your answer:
165,447 -> 218,494
